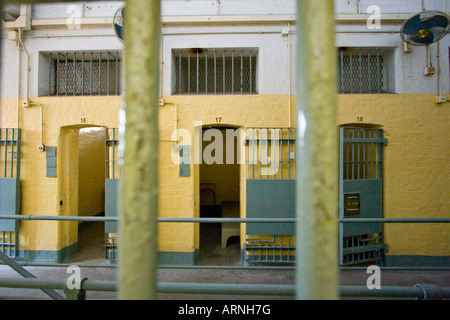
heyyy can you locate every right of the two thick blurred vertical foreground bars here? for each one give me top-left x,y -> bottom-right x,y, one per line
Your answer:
296,0 -> 338,299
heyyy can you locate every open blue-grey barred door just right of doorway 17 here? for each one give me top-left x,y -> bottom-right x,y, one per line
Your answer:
244,128 -> 295,264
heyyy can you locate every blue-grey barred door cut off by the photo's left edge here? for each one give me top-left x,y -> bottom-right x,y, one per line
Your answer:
0,128 -> 21,258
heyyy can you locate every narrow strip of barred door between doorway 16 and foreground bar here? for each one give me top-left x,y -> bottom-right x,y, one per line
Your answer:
105,128 -> 119,260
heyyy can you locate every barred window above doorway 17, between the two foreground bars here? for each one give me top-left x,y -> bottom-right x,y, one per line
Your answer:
172,48 -> 258,95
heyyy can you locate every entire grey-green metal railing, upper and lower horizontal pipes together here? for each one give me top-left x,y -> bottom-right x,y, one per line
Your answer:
0,215 -> 450,300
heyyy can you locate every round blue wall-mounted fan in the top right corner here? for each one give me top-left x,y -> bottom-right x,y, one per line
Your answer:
400,11 -> 449,46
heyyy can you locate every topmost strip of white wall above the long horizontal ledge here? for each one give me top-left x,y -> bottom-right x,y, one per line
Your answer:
29,0 -> 447,19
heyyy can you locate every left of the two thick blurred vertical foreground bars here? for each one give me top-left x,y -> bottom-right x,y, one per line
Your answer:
118,0 -> 161,299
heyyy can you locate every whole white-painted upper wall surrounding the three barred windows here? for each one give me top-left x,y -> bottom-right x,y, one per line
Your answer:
0,0 -> 450,97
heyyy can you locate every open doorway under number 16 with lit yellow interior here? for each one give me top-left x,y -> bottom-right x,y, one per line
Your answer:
57,125 -> 105,262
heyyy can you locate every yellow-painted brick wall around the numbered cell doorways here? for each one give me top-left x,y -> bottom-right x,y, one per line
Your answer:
0,94 -> 450,256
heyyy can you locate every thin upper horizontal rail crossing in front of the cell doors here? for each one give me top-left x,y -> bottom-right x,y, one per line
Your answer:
0,215 -> 450,223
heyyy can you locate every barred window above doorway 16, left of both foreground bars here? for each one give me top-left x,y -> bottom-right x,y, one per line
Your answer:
39,51 -> 122,96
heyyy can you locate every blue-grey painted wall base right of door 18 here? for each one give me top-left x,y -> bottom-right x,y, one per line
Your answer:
384,255 -> 450,267
